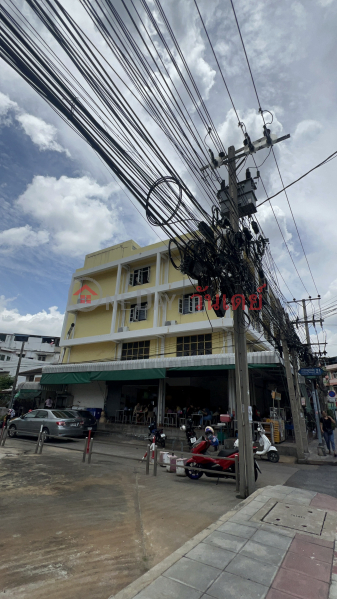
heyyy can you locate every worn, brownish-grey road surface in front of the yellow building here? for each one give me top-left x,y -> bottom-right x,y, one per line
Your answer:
0,438 -> 336,599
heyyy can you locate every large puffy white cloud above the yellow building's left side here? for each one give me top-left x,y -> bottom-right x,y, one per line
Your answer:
16,176 -> 127,256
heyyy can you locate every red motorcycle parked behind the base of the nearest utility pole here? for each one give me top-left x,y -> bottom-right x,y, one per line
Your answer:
185,437 -> 261,480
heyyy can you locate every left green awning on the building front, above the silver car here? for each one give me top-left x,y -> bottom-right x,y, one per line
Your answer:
40,368 -> 166,385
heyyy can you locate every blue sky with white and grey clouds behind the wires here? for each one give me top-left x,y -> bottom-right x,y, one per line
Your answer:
0,0 -> 337,356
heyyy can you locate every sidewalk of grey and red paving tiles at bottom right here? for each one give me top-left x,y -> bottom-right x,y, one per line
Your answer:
110,485 -> 337,599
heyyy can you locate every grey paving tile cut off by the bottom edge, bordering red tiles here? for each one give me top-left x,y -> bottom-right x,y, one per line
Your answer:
205,572 -> 268,599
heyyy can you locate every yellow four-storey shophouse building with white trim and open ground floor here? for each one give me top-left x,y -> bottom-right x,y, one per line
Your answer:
41,240 -> 283,422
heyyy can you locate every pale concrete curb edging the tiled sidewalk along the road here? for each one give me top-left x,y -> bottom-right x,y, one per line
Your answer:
108,485 -> 266,599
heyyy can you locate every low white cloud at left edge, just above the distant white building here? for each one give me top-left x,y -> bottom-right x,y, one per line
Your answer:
0,295 -> 64,336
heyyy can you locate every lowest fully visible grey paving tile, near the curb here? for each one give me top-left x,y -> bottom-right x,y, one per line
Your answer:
163,557 -> 221,591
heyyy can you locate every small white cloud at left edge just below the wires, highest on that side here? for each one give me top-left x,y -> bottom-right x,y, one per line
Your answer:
0,92 -> 70,157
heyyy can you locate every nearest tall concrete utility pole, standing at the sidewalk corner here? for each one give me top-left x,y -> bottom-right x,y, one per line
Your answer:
228,146 -> 255,498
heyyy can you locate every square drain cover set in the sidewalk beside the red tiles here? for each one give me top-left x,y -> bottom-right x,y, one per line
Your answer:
263,503 -> 327,535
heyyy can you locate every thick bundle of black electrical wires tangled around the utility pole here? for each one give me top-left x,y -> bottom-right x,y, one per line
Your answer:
0,0 -> 303,364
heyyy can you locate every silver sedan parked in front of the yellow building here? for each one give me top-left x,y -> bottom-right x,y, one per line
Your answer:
8,410 -> 84,437
